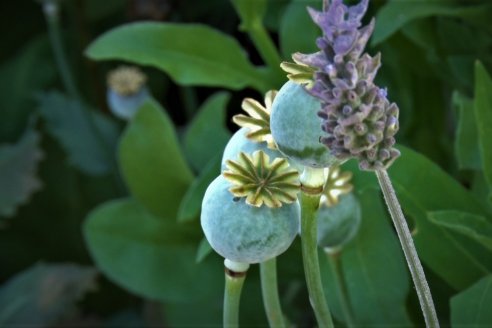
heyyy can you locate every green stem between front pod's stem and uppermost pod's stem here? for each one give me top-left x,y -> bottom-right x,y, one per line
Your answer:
260,258 -> 287,328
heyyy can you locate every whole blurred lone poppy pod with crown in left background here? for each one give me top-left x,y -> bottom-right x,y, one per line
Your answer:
106,66 -> 150,121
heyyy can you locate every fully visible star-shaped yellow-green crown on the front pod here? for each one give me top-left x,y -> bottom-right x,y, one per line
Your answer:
222,150 -> 301,208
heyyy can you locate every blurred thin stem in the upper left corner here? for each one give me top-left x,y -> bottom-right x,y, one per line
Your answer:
43,1 -> 80,99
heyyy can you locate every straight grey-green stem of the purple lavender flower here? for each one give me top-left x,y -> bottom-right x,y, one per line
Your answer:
376,169 -> 439,328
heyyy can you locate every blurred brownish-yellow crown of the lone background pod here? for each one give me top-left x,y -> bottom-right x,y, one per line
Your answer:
107,66 -> 147,96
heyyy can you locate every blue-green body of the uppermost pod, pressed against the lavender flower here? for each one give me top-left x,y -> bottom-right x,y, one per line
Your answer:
270,81 -> 340,167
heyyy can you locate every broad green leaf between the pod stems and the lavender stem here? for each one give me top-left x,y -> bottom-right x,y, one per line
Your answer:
321,190 -> 410,327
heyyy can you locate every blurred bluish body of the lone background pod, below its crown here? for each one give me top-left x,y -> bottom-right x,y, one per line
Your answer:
106,87 -> 149,120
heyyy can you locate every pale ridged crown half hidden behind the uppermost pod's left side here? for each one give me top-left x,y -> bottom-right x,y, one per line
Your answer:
232,90 -> 277,149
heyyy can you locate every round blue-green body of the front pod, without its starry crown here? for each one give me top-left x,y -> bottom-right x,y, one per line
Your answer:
200,176 -> 300,264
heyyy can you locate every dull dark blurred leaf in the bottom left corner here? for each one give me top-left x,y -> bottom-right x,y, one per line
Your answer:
0,264 -> 97,327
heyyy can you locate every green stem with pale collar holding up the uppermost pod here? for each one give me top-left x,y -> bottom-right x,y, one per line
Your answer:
300,166 -> 334,328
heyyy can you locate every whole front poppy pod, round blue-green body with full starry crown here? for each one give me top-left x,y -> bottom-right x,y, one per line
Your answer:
200,151 -> 300,264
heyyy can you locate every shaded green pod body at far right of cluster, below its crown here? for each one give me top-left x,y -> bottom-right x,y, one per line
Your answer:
317,193 -> 361,252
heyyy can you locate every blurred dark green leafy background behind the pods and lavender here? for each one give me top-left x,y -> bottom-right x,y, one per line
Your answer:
0,0 -> 492,327
